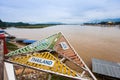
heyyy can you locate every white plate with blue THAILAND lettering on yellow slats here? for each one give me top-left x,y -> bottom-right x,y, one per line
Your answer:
28,57 -> 55,67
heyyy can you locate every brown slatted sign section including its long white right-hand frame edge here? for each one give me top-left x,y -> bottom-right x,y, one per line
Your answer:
54,34 -> 97,80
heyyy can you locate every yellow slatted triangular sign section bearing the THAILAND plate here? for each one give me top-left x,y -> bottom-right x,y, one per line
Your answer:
7,52 -> 86,80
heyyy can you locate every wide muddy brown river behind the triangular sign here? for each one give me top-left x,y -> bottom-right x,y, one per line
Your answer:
6,25 -> 120,68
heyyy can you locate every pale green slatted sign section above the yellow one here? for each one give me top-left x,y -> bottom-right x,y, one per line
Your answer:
6,33 -> 60,56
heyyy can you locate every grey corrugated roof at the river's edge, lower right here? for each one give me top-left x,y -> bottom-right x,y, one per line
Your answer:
92,58 -> 120,79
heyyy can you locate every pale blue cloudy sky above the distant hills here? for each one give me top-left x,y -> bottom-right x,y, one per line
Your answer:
0,0 -> 120,23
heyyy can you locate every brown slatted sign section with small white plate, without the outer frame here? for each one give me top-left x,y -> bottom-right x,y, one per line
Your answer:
54,35 -> 84,67
